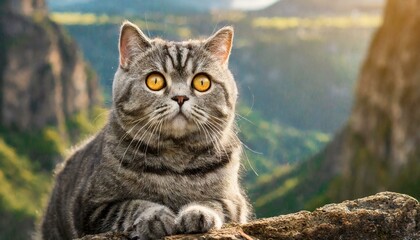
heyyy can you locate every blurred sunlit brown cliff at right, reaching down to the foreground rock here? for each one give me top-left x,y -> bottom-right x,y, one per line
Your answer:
325,0 -> 420,199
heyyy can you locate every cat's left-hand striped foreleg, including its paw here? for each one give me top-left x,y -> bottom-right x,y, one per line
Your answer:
88,200 -> 176,239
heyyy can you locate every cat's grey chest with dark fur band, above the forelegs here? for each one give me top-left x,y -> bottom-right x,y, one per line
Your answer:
101,146 -> 233,209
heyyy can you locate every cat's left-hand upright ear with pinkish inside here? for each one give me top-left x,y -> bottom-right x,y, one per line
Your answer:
119,21 -> 152,69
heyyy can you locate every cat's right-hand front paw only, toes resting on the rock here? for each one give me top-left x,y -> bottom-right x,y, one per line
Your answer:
175,205 -> 223,233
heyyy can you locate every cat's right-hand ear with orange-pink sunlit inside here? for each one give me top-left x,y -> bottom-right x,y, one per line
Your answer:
204,27 -> 233,64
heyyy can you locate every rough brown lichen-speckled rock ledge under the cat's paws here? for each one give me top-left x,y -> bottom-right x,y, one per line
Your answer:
78,192 -> 420,240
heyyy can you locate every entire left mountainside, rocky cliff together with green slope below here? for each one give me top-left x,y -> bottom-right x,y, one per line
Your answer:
0,0 -> 101,239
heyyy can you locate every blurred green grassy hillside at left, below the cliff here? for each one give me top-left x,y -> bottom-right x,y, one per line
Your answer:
0,108 -> 106,240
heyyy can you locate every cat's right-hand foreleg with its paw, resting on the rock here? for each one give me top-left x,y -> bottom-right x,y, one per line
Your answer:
175,198 -> 249,233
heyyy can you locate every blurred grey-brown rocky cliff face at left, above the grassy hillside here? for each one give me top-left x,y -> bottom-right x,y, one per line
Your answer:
0,0 -> 100,130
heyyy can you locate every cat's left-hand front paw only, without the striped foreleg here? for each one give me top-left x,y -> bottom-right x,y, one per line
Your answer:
131,206 -> 176,240
